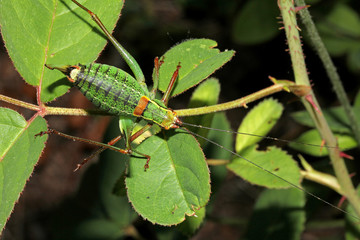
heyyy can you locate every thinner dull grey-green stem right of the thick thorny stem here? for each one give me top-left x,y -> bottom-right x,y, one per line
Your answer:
296,0 -> 360,150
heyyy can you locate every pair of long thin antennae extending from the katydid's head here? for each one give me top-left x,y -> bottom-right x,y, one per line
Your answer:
180,123 -> 360,220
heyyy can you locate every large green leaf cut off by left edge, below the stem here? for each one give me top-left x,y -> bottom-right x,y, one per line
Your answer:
0,108 -> 47,231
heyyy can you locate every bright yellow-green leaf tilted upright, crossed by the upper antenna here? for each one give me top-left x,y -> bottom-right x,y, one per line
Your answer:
235,98 -> 283,153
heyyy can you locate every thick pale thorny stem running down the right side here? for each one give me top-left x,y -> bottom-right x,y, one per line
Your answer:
278,0 -> 360,216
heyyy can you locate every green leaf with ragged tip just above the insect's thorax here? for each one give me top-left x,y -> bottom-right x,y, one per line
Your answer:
159,39 -> 235,96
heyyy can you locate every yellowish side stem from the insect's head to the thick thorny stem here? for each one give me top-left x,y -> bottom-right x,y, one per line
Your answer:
176,80 -> 294,117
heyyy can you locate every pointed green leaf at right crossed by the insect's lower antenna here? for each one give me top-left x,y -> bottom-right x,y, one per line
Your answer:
227,146 -> 300,188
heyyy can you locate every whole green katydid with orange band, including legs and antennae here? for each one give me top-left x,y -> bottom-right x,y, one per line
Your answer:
41,0 -> 358,222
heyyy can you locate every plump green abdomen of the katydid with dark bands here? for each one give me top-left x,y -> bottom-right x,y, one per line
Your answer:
74,64 -> 144,115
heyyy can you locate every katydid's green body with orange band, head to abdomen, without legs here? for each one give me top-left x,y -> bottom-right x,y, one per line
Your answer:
63,63 -> 179,129
